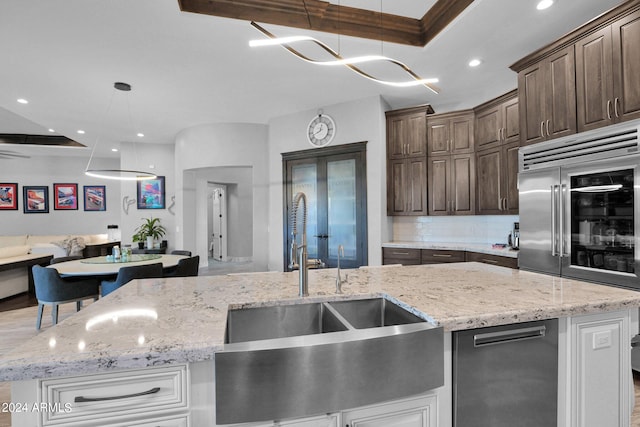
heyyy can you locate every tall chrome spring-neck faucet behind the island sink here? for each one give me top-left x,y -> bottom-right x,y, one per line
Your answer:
289,192 -> 325,297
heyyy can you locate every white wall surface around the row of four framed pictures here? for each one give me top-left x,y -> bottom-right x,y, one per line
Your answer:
0,156 -> 120,235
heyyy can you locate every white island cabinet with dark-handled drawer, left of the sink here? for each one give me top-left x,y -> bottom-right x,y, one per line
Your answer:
12,364 -> 190,427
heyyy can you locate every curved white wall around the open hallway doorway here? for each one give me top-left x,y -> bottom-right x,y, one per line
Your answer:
175,123 -> 270,269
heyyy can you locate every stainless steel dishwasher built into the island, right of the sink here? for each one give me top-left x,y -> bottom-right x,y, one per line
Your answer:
453,319 -> 558,427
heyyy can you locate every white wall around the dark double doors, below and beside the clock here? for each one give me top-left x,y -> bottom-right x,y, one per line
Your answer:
267,97 -> 391,270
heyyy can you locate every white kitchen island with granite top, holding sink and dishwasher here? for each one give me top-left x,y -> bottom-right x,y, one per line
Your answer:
0,263 -> 640,427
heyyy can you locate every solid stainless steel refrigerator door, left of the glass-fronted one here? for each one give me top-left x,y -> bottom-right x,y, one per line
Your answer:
518,168 -> 560,275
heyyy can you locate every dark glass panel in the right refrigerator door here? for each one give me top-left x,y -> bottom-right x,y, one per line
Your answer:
570,169 -> 635,273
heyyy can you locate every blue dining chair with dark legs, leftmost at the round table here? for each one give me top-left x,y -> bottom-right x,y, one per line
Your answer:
31,265 -> 99,330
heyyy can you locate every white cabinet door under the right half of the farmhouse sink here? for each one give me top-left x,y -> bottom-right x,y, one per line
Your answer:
342,395 -> 437,427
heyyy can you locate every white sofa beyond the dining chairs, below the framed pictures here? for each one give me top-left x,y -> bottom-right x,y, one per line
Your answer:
0,234 -> 108,299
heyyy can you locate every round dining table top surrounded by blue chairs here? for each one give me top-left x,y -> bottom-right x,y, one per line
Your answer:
47,254 -> 188,277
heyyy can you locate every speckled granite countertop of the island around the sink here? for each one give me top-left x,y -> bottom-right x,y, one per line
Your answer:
0,263 -> 640,381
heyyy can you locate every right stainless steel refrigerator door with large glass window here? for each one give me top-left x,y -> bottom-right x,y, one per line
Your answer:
560,155 -> 640,290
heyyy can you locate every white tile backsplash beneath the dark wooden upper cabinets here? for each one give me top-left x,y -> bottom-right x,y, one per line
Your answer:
393,215 -> 519,244
